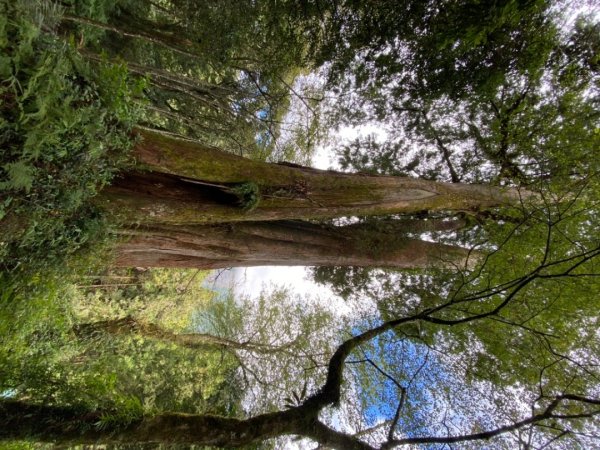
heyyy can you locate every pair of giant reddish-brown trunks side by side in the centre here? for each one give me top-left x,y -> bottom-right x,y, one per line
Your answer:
98,129 -> 522,269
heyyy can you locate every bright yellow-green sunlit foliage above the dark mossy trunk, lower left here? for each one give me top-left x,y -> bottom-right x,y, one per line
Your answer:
0,270 -> 236,418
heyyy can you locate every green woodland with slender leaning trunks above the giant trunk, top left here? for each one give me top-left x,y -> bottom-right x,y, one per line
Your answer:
62,0 -> 322,161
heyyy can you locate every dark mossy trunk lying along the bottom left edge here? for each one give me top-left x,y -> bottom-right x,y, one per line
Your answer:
0,400 -> 373,450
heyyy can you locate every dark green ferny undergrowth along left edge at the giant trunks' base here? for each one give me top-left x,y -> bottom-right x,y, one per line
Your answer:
0,0 -> 145,284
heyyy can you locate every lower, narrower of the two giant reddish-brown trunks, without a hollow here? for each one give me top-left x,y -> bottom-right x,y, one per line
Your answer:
116,221 -> 476,269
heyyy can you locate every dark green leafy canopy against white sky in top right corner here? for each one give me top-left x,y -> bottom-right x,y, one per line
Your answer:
308,1 -> 598,189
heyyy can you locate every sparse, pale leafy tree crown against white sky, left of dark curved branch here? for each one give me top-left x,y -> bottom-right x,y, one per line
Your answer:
193,286 -> 346,413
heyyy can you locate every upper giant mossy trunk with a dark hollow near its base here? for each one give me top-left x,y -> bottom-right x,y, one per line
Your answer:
103,126 -> 520,225
